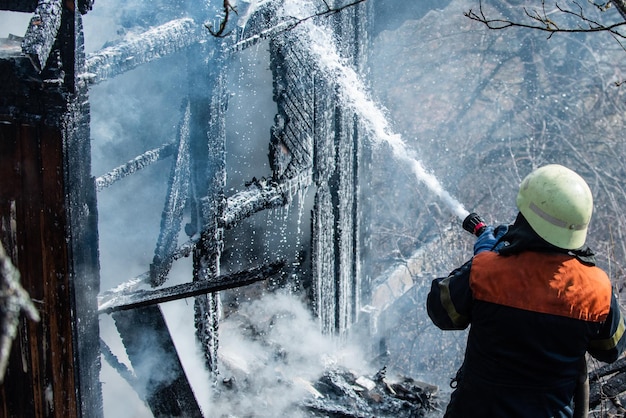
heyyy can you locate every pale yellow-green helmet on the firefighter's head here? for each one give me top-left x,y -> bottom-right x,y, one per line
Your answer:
517,164 -> 593,250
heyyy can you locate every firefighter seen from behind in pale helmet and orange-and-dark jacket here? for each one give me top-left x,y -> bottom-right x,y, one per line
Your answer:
427,164 -> 626,418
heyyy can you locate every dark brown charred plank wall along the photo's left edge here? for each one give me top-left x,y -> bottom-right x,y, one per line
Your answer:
0,2 -> 102,418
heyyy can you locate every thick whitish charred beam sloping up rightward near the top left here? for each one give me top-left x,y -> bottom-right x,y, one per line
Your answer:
83,18 -> 207,84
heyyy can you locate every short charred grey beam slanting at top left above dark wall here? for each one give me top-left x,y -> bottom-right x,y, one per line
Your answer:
22,0 -> 63,72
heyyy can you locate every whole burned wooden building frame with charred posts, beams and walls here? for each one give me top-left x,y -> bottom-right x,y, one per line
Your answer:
0,0 -> 369,417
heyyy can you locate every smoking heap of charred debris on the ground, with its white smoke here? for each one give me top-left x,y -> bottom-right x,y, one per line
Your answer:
212,294 -> 442,418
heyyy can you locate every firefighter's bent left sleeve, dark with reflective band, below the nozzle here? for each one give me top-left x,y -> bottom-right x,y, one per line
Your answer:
426,261 -> 473,330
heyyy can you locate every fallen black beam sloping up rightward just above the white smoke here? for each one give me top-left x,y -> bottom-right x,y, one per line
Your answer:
99,261 -> 285,313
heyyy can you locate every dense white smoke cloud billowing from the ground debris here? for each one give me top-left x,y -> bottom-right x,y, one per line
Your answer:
211,293 -> 369,417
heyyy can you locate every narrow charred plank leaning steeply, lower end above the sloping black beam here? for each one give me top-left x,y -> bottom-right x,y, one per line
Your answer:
150,103 -> 191,287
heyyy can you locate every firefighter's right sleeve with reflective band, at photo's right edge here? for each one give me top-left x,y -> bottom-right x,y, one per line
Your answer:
588,294 -> 626,363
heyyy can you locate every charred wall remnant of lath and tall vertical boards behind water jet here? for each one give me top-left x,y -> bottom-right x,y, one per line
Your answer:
270,11 -> 366,335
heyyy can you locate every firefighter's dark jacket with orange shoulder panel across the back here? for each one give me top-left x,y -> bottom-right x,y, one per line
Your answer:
427,219 -> 626,418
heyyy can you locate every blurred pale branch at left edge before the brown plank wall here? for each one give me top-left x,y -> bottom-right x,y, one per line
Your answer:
0,238 -> 39,383
